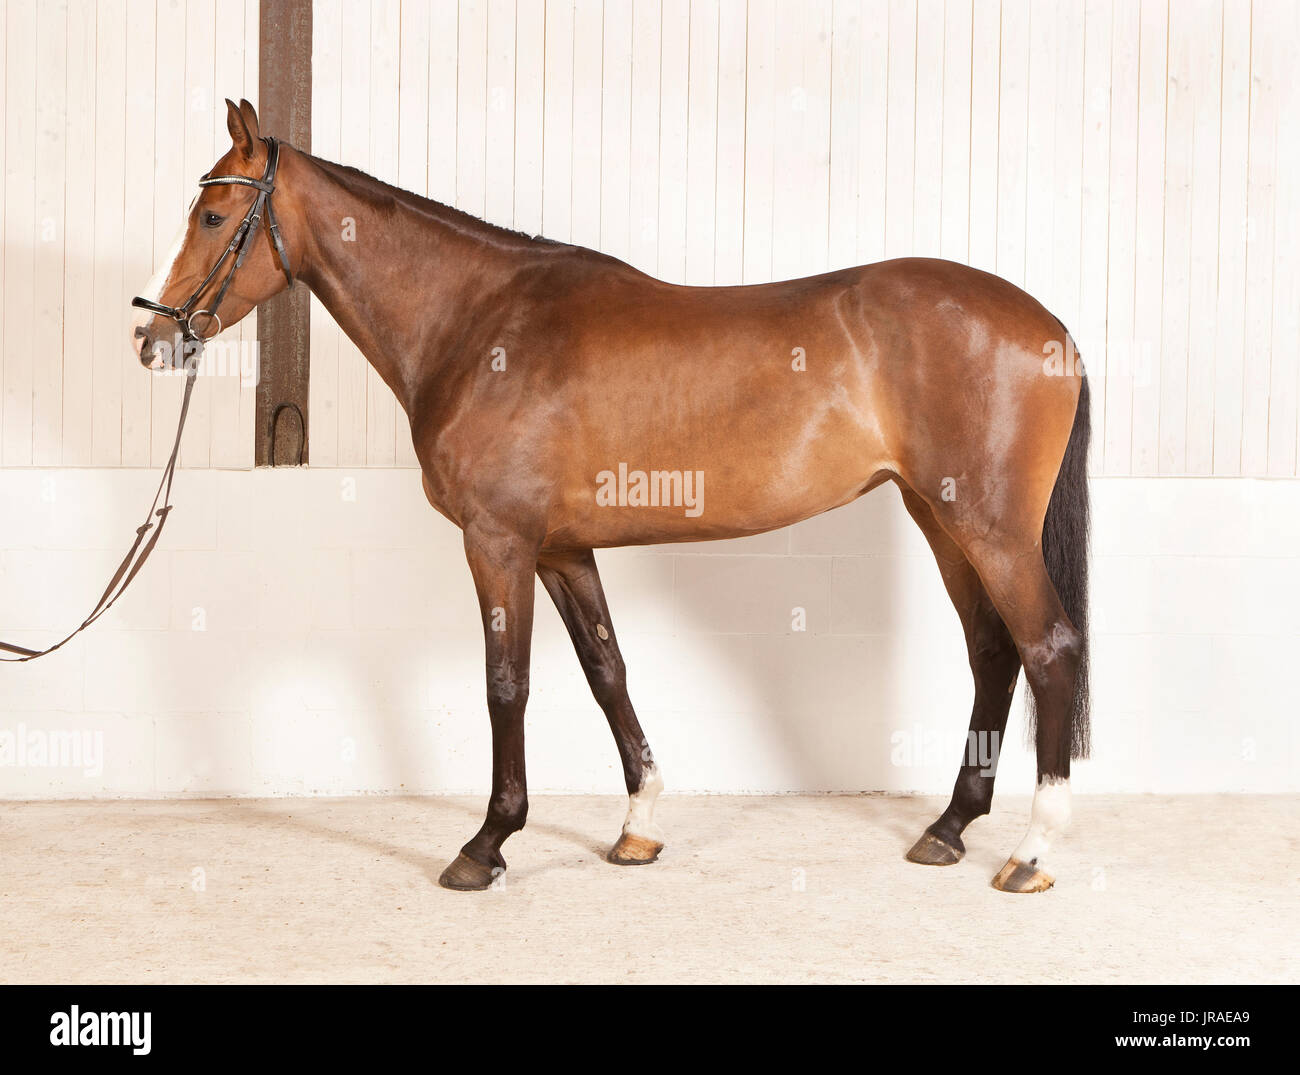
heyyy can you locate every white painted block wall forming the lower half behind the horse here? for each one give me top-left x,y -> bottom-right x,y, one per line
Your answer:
0,469 -> 1300,798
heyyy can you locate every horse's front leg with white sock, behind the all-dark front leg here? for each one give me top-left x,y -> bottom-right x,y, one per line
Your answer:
537,550 -> 663,866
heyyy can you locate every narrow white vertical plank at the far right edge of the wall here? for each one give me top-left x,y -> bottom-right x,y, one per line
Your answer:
1269,4 -> 1300,477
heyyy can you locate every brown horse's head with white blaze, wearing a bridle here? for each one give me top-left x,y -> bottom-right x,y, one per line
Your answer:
131,100 -> 301,369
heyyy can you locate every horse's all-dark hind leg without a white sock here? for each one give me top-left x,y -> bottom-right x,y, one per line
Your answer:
900,486 -> 1021,866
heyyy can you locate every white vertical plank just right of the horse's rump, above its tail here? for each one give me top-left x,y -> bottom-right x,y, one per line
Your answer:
1081,0 -> 1113,473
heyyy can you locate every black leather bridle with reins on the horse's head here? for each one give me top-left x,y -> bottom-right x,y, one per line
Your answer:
0,138 -> 294,663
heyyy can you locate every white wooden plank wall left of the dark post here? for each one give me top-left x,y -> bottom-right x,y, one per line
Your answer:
0,0 -> 257,467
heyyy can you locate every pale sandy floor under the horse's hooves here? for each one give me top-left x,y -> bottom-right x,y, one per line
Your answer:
0,796 -> 1300,983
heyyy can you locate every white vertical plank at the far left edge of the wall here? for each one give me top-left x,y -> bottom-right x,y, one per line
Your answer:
0,0 -> 36,467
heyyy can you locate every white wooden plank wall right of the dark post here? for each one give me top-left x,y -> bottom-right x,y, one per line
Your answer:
312,0 -> 1300,476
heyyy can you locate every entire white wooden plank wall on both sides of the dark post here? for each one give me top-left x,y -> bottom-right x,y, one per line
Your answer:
0,0 -> 1300,476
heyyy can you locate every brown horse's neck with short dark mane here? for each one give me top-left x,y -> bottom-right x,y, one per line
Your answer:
295,153 -> 528,415
